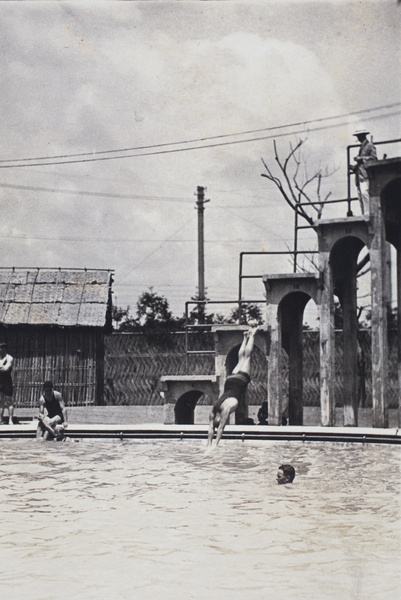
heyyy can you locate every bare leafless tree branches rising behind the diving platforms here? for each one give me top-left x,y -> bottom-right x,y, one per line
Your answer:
262,140 -> 334,225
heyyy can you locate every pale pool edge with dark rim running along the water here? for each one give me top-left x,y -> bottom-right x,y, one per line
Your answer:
0,420 -> 401,444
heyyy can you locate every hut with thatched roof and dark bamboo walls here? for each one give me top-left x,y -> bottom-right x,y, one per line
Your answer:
0,268 -> 113,406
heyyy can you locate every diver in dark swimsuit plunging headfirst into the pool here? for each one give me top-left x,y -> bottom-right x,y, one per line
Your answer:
207,327 -> 258,448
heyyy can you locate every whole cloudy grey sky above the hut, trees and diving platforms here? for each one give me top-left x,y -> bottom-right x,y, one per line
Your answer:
0,0 -> 401,315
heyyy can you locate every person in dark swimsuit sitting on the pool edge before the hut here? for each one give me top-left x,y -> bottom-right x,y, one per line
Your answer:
36,381 -> 68,441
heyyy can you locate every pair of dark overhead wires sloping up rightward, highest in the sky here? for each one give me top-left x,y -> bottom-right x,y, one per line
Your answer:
0,102 -> 401,169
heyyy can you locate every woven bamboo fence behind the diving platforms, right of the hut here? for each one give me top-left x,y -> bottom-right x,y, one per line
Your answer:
105,331 -> 398,408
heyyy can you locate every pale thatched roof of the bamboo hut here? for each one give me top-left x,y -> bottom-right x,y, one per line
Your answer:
0,268 -> 112,327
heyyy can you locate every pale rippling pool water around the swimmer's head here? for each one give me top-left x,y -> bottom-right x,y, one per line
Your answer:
0,439 -> 401,600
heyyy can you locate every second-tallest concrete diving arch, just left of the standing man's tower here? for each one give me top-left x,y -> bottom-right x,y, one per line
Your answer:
315,215 -> 381,426
